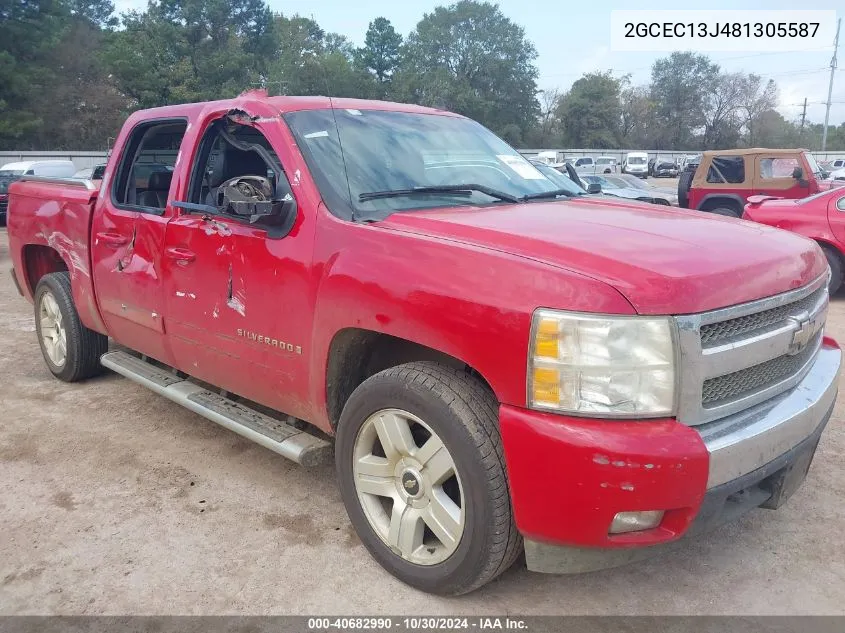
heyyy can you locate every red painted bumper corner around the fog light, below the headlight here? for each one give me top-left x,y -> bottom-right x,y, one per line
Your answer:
499,406 -> 709,547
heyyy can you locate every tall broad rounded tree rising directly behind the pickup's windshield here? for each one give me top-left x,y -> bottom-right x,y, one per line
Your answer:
391,0 -> 538,138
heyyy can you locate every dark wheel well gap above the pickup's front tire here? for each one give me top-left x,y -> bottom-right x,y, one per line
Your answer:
325,327 -> 494,429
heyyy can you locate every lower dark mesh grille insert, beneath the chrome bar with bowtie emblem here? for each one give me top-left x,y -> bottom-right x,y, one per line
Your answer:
701,334 -> 821,407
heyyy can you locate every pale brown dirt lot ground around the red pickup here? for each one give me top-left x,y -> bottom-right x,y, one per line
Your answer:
0,229 -> 845,615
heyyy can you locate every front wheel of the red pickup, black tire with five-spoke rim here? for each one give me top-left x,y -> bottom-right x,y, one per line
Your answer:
335,362 -> 522,595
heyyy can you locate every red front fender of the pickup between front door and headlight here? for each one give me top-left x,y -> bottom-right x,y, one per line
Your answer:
310,212 -> 634,428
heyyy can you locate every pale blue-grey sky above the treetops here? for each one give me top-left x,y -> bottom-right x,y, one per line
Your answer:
115,0 -> 845,124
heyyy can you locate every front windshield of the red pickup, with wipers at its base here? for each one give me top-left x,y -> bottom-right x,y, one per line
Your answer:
285,109 -> 560,220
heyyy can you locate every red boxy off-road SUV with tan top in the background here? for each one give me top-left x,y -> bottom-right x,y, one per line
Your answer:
678,148 -> 831,218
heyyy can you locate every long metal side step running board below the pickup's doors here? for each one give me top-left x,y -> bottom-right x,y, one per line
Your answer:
100,351 -> 332,466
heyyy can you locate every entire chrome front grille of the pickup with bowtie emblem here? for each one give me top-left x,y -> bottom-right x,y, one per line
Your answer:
675,275 -> 828,425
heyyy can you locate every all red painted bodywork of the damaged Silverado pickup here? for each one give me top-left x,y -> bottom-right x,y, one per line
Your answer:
1,94 -> 825,546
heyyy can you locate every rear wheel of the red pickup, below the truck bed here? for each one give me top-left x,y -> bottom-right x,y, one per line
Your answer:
34,272 -> 109,382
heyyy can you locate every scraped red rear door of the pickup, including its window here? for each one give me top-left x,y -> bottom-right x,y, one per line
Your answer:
91,119 -> 187,362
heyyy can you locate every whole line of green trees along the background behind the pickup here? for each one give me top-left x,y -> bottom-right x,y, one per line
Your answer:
0,0 -> 845,150
